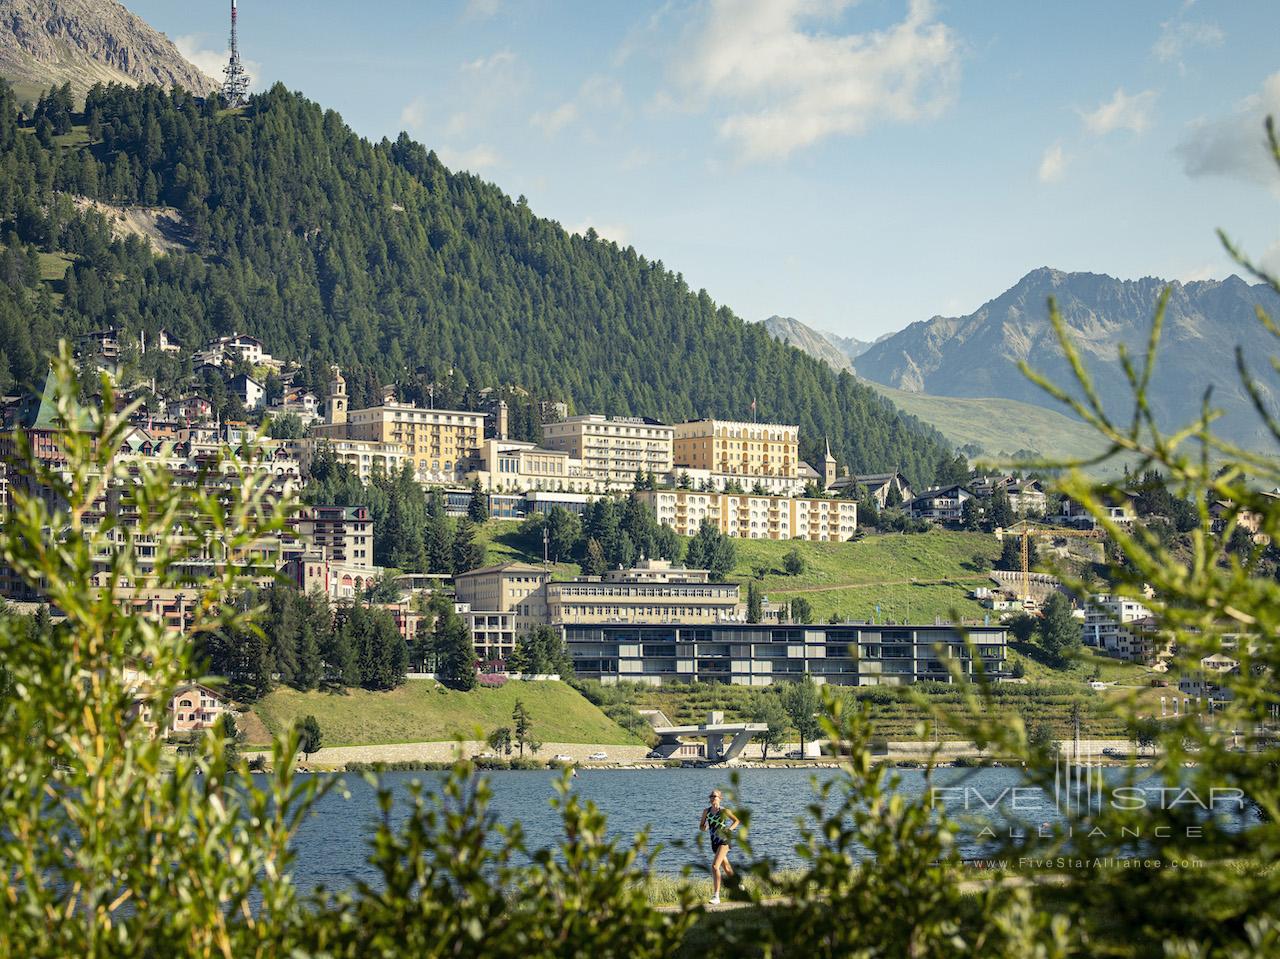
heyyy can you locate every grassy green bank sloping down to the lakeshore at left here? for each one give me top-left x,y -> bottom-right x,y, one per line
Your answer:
250,680 -> 640,746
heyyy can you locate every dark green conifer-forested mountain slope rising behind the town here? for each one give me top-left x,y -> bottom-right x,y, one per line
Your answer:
0,86 -> 946,483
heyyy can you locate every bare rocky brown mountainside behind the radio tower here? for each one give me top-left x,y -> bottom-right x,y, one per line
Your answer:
0,0 -> 218,99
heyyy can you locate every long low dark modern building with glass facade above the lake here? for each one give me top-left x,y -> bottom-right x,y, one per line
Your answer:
562,624 -> 1007,686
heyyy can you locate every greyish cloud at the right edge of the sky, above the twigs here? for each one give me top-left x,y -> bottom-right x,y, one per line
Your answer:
1176,73 -> 1280,191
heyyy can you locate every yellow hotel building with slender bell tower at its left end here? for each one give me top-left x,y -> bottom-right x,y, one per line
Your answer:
311,383 -> 485,483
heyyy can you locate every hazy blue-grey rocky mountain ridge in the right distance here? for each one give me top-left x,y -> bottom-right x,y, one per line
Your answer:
855,268 -> 1280,444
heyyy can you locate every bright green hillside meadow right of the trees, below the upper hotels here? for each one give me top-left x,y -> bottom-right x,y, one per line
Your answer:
730,530 -> 1000,622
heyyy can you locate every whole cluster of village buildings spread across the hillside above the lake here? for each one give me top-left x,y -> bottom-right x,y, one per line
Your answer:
0,323 -> 1226,731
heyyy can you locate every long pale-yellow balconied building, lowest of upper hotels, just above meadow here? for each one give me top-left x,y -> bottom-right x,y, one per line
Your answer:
632,489 -> 858,543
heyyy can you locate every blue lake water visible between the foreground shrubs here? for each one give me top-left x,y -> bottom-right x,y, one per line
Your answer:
294,768 -> 1100,889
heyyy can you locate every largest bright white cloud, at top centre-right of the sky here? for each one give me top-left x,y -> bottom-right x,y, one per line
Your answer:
677,0 -> 960,159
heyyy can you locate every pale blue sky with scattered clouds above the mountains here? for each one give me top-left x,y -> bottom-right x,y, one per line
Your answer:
125,0 -> 1280,339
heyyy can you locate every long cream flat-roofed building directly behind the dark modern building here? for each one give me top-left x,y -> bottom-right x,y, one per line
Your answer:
547,560 -> 744,625
